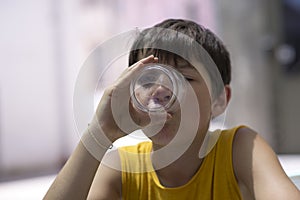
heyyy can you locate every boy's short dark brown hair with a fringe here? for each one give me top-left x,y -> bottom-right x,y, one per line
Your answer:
129,19 -> 231,94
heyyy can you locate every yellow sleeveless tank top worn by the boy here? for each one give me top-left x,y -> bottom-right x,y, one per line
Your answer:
119,127 -> 242,200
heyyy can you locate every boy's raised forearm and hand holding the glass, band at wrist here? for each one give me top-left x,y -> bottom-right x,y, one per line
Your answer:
44,56 -> 157,200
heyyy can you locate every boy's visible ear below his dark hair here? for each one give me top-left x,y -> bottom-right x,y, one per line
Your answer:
212,85 -> 231,118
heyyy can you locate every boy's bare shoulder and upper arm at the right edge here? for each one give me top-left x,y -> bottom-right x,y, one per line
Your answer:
232,127 -> 300,200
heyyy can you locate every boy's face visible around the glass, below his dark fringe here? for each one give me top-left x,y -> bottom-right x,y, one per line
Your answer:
144,57 -> 211,146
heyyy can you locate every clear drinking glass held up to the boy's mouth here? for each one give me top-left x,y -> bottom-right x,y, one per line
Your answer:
130,64 -> 186,112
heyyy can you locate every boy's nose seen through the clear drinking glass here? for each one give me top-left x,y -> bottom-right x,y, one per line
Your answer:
151,85 -> 172,106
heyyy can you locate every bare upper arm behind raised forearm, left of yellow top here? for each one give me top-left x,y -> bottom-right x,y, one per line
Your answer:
88,150 -> 122,200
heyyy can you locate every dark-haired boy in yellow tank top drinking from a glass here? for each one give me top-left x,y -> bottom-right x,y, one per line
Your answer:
45,19 -> 300,200
